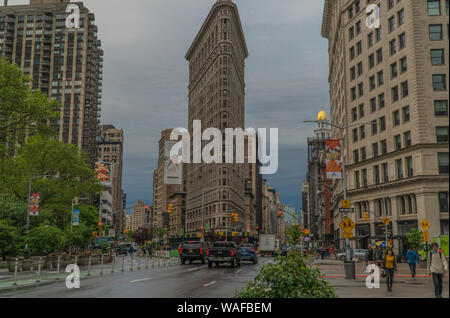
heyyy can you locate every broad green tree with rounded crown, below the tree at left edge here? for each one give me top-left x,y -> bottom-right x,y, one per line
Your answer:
0,136 -> 102,229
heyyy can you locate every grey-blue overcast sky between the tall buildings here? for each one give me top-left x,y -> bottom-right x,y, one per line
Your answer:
9,0 -> 329,214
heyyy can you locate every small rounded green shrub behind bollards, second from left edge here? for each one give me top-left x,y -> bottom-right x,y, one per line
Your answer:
25,224 -> 63,255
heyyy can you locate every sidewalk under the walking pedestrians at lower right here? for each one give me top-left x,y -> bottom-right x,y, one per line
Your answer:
312,259 -> 449,298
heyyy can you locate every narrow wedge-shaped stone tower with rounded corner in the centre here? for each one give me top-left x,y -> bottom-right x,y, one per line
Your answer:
186,0 -> 248,234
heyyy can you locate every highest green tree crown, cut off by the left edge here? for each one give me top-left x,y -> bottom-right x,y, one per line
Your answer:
0,58 -> 61,157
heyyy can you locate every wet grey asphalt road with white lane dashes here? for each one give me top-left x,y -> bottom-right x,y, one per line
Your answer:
0,257 -> 273,298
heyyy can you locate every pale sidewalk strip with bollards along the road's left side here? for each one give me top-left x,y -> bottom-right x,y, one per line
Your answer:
0,256 -> 179,297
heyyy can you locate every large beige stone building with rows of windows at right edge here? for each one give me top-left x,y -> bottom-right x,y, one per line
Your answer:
322,0 -> 449,251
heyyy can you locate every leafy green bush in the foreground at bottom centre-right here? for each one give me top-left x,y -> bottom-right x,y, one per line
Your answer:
236,249 -> 337,298
